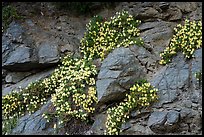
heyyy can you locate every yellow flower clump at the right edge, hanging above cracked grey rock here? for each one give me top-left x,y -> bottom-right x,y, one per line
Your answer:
159,19 -> 202,65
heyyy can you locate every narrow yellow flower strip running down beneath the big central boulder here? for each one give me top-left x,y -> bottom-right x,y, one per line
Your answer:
105,81 -> 158,135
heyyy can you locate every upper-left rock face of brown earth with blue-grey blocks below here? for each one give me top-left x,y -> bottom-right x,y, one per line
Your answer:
2,16 -> 85,71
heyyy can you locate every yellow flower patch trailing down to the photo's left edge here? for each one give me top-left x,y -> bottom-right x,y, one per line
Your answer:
2,81 -> 51,119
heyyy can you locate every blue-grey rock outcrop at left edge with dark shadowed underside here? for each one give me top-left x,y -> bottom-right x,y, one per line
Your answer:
2,22 -> 59,71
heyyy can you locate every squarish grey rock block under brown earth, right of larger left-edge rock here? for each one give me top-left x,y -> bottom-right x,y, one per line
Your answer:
38,42 -> 59,64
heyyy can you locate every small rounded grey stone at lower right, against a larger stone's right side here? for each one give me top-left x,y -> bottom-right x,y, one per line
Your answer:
167,110 -> 179,125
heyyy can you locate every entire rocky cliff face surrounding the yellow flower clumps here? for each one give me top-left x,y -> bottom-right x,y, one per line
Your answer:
2,2 -> 202,135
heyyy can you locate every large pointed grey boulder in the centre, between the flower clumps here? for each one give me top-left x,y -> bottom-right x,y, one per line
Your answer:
96,47 -> 144,103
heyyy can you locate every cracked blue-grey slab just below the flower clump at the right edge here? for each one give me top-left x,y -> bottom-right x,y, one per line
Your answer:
150,53 -> 193,107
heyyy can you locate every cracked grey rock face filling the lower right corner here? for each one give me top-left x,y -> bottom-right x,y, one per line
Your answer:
122,48 -> 202,134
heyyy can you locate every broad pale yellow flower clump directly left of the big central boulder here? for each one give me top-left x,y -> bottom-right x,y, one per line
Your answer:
45,56 -> 97,123
